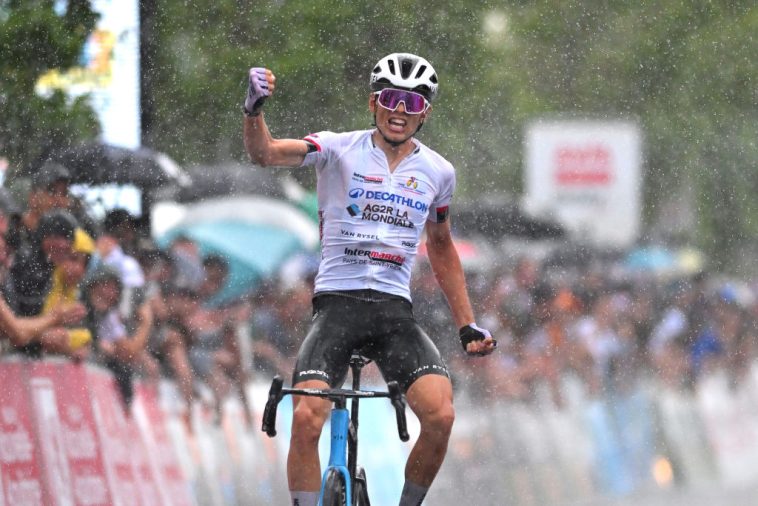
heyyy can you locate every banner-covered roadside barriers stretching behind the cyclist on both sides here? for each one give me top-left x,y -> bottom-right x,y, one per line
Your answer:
0,359 -> 758,506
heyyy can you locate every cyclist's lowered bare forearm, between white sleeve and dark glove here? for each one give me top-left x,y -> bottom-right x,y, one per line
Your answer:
426,221 -> 474,328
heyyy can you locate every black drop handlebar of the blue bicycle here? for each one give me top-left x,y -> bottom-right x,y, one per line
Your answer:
261,376 -> 409,441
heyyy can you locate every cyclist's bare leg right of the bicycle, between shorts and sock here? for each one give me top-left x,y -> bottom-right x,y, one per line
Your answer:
400,374 -> 455,505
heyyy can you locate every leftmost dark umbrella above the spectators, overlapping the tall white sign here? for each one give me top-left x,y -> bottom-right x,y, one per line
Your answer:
34,143 -> 192,189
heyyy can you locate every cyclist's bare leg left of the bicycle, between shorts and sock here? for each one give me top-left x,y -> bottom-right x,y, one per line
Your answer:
287,380 -> 331,498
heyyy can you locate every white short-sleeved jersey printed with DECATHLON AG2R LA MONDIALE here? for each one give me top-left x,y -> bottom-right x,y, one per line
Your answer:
303,130 -> 455,300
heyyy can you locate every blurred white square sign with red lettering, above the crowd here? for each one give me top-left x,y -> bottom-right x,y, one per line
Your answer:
524,120 -> 642,247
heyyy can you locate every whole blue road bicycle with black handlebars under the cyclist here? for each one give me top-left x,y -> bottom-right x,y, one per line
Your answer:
261,353 -> 409,506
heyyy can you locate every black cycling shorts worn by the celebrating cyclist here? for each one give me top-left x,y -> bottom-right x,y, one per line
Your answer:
292,290 -> 450,391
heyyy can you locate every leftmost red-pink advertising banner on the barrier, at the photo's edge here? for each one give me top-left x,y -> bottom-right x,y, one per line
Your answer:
0,362 -> 45,506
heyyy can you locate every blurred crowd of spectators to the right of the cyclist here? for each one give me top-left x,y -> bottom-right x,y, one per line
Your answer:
451,258 -> 758,406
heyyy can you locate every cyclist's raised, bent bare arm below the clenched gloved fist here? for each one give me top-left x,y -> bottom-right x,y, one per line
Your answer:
243,114 -> 313,167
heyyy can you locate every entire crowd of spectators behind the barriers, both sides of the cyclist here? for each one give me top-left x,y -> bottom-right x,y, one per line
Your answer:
0,163 -> 758,426
